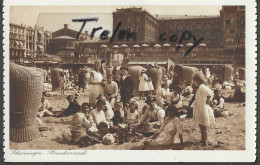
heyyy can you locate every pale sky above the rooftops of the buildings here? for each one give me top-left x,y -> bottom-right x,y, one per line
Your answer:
10,6 -> 221,35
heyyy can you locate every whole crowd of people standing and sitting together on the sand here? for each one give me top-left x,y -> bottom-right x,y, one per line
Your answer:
38,60 -> 245,146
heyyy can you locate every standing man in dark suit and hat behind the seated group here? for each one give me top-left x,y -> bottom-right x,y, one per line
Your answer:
120,67 -> 134,107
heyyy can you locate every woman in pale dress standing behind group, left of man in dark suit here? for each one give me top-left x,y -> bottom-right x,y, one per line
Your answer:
89,60 -> 104,107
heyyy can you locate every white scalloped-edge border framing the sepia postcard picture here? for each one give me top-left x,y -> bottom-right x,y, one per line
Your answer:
3,0 -> 257,162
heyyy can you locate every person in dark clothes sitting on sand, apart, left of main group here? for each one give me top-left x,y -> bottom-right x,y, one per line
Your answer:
57,95 -> 80,117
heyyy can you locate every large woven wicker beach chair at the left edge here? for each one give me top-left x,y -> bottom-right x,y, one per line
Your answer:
10,62 -> 43,142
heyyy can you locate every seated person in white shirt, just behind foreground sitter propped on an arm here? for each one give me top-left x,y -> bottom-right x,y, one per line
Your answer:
133,96 -> 165,128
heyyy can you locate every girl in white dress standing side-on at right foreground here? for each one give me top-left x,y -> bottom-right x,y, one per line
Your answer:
193,72 -> 215,145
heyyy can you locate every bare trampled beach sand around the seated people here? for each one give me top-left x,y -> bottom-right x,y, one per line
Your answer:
10,88 -> 245,150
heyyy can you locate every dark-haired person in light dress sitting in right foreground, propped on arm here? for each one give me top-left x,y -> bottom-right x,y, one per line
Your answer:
150,105 -> 183,146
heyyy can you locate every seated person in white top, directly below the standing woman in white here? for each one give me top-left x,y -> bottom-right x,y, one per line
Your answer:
90,96 -> 108,126
